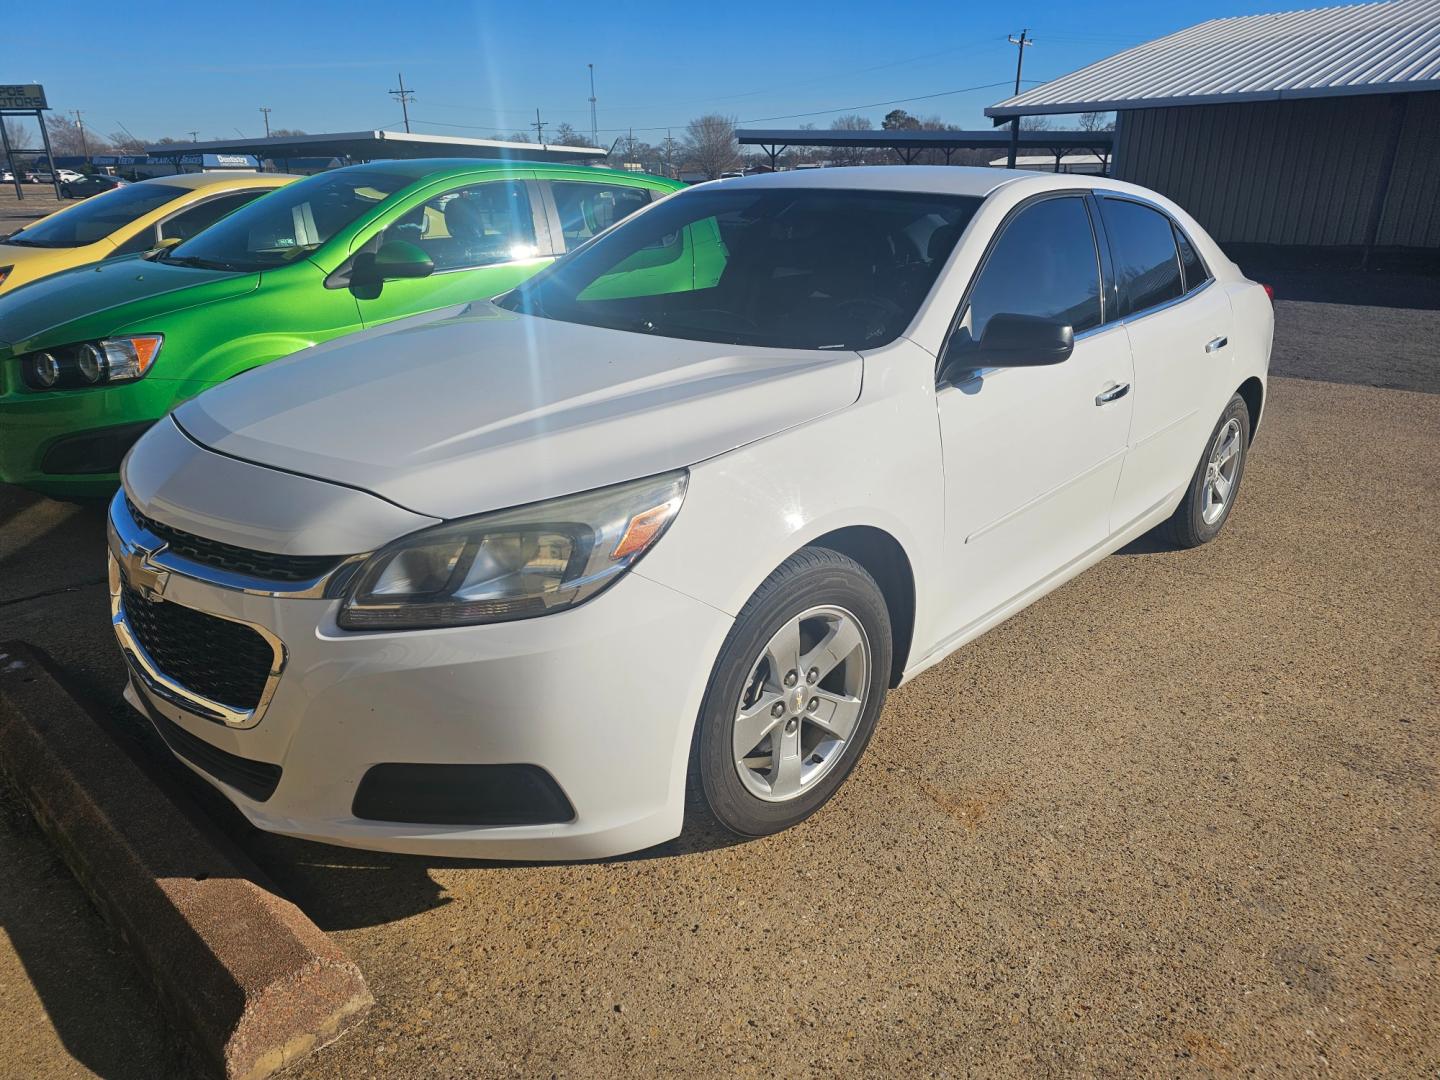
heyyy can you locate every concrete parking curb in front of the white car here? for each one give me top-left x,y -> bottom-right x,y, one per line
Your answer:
0,642 -> 373,1080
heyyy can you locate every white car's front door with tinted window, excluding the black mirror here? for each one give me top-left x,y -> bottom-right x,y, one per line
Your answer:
936,194 -> 1133,636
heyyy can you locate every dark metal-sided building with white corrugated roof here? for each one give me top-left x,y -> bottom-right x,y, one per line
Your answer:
985,0 -> 1440,249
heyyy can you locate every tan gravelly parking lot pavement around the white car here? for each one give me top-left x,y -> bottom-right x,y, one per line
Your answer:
0,252 -> 1440,1077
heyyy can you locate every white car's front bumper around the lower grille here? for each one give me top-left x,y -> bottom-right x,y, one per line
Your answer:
111,498 -> 732,860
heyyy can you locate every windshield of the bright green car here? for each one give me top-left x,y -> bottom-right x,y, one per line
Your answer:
164,168 -> 413,271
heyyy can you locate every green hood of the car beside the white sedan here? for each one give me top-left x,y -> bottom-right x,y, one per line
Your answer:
0,258 -> 261,347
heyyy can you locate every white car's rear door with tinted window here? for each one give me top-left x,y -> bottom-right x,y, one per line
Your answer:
1099,194 -> 1231,530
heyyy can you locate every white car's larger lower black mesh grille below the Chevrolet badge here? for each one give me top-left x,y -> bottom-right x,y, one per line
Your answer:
121,585 -> 275,708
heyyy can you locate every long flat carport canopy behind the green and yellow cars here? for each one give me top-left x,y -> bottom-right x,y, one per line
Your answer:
137,131 -> 606,164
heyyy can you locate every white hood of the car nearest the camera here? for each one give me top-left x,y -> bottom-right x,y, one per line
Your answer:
174,304 -> 863,518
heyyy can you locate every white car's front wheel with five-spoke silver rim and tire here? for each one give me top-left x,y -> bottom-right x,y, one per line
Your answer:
691,547 -> 891,837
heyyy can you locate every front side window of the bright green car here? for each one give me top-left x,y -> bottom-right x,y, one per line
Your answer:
380,180 -> 539,272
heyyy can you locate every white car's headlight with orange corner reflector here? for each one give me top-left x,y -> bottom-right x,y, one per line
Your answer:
338,469 -> 688,629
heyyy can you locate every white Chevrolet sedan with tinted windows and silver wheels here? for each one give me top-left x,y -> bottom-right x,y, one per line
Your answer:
118,167 -> 1272,858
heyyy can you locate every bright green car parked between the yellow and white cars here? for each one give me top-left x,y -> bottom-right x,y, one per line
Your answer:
0,160 -> 681,497
